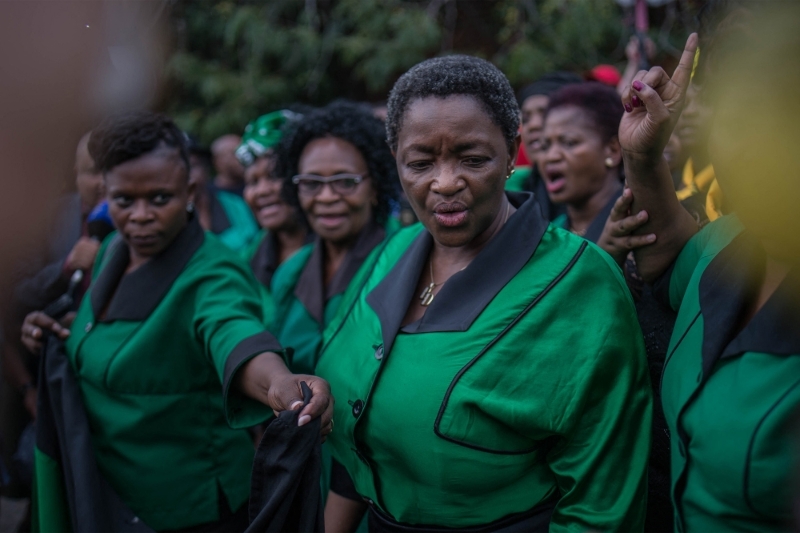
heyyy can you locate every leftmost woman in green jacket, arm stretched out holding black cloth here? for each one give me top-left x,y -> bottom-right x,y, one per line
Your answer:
23,112 -> 332,531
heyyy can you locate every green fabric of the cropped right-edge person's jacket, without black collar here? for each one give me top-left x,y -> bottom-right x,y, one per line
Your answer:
660,215 -> 800,531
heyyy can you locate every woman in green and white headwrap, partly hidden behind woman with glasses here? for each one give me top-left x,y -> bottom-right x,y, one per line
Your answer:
236,110 -> 312,324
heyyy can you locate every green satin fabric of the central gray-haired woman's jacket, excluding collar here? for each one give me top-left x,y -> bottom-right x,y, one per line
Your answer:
317,224 -> 652,532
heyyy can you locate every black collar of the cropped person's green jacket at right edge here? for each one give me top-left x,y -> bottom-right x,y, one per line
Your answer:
699,231 -> 800,378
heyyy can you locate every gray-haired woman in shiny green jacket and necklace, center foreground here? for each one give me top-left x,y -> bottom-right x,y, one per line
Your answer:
317,56 -> 651,531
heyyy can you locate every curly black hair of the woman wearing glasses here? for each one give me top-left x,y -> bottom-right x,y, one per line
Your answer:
275,100 -> 400,224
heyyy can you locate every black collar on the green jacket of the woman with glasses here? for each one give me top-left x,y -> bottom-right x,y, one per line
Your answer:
294,217 -> 386,324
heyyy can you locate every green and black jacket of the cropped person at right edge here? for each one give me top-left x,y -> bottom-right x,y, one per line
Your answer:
656,215 -> 800,531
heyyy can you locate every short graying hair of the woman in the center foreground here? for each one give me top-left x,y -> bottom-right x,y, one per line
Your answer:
386,55 -> 520,150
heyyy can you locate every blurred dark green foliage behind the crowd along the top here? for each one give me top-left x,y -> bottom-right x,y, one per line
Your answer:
164,0 -> 697,143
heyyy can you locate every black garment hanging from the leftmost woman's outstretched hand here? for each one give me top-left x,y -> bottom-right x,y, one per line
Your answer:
247,382 -> 325,533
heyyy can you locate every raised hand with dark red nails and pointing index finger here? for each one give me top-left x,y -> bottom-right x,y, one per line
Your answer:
619,33 -> 697,161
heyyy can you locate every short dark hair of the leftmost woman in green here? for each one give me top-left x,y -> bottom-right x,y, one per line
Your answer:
89,111 -> 189,177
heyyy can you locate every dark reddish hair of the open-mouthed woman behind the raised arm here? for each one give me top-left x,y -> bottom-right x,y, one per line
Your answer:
547,81 -> 624,142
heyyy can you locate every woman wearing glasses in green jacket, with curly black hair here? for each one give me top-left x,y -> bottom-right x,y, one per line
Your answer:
269,102 -> 398,373
